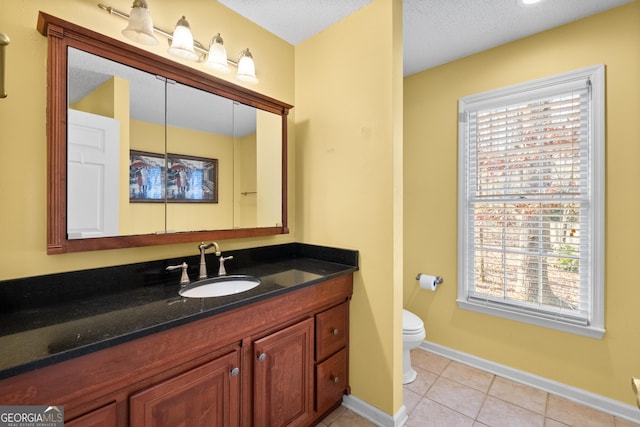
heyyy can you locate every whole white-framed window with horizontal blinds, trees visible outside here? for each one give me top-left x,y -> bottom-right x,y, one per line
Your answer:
458,65 -> 604,338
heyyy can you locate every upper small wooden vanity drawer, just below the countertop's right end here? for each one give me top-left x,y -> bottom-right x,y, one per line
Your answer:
316,302 -> 349,362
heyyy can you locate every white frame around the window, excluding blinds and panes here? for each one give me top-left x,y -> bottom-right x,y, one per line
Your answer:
457,64 -> 605,338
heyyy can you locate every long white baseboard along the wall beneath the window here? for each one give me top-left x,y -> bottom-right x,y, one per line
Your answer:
420,341 -> 640,423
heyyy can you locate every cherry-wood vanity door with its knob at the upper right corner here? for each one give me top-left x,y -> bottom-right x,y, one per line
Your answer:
129,350 -> 240,427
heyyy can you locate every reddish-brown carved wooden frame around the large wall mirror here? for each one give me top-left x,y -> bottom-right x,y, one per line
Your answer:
37,12 -> 293,255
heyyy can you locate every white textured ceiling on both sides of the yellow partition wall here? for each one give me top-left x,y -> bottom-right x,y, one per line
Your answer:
218,0 -> 634,76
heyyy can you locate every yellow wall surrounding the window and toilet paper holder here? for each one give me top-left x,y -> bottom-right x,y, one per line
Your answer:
404,1 -> 640,404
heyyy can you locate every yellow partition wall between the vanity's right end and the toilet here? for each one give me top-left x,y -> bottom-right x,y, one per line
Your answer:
295,0 -> 402,414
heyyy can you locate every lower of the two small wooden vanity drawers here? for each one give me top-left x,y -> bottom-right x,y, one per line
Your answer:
316,348 -> 348,413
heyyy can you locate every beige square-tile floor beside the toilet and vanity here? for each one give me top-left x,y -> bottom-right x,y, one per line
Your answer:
318,349 -> 640,427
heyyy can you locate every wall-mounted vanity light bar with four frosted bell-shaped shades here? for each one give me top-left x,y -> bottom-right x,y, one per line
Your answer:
98,0 -> 258,84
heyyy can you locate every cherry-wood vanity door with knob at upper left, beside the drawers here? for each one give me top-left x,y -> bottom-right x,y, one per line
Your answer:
253,319 -> 314,427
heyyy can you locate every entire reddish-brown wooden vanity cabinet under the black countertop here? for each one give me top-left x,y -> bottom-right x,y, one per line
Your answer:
0,274 -> 353,427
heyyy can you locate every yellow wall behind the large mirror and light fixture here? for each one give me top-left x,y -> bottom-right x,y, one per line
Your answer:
0,0 -> 295,280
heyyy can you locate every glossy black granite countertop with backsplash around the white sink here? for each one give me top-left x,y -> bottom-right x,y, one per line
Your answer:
0,243 -> 358,379
